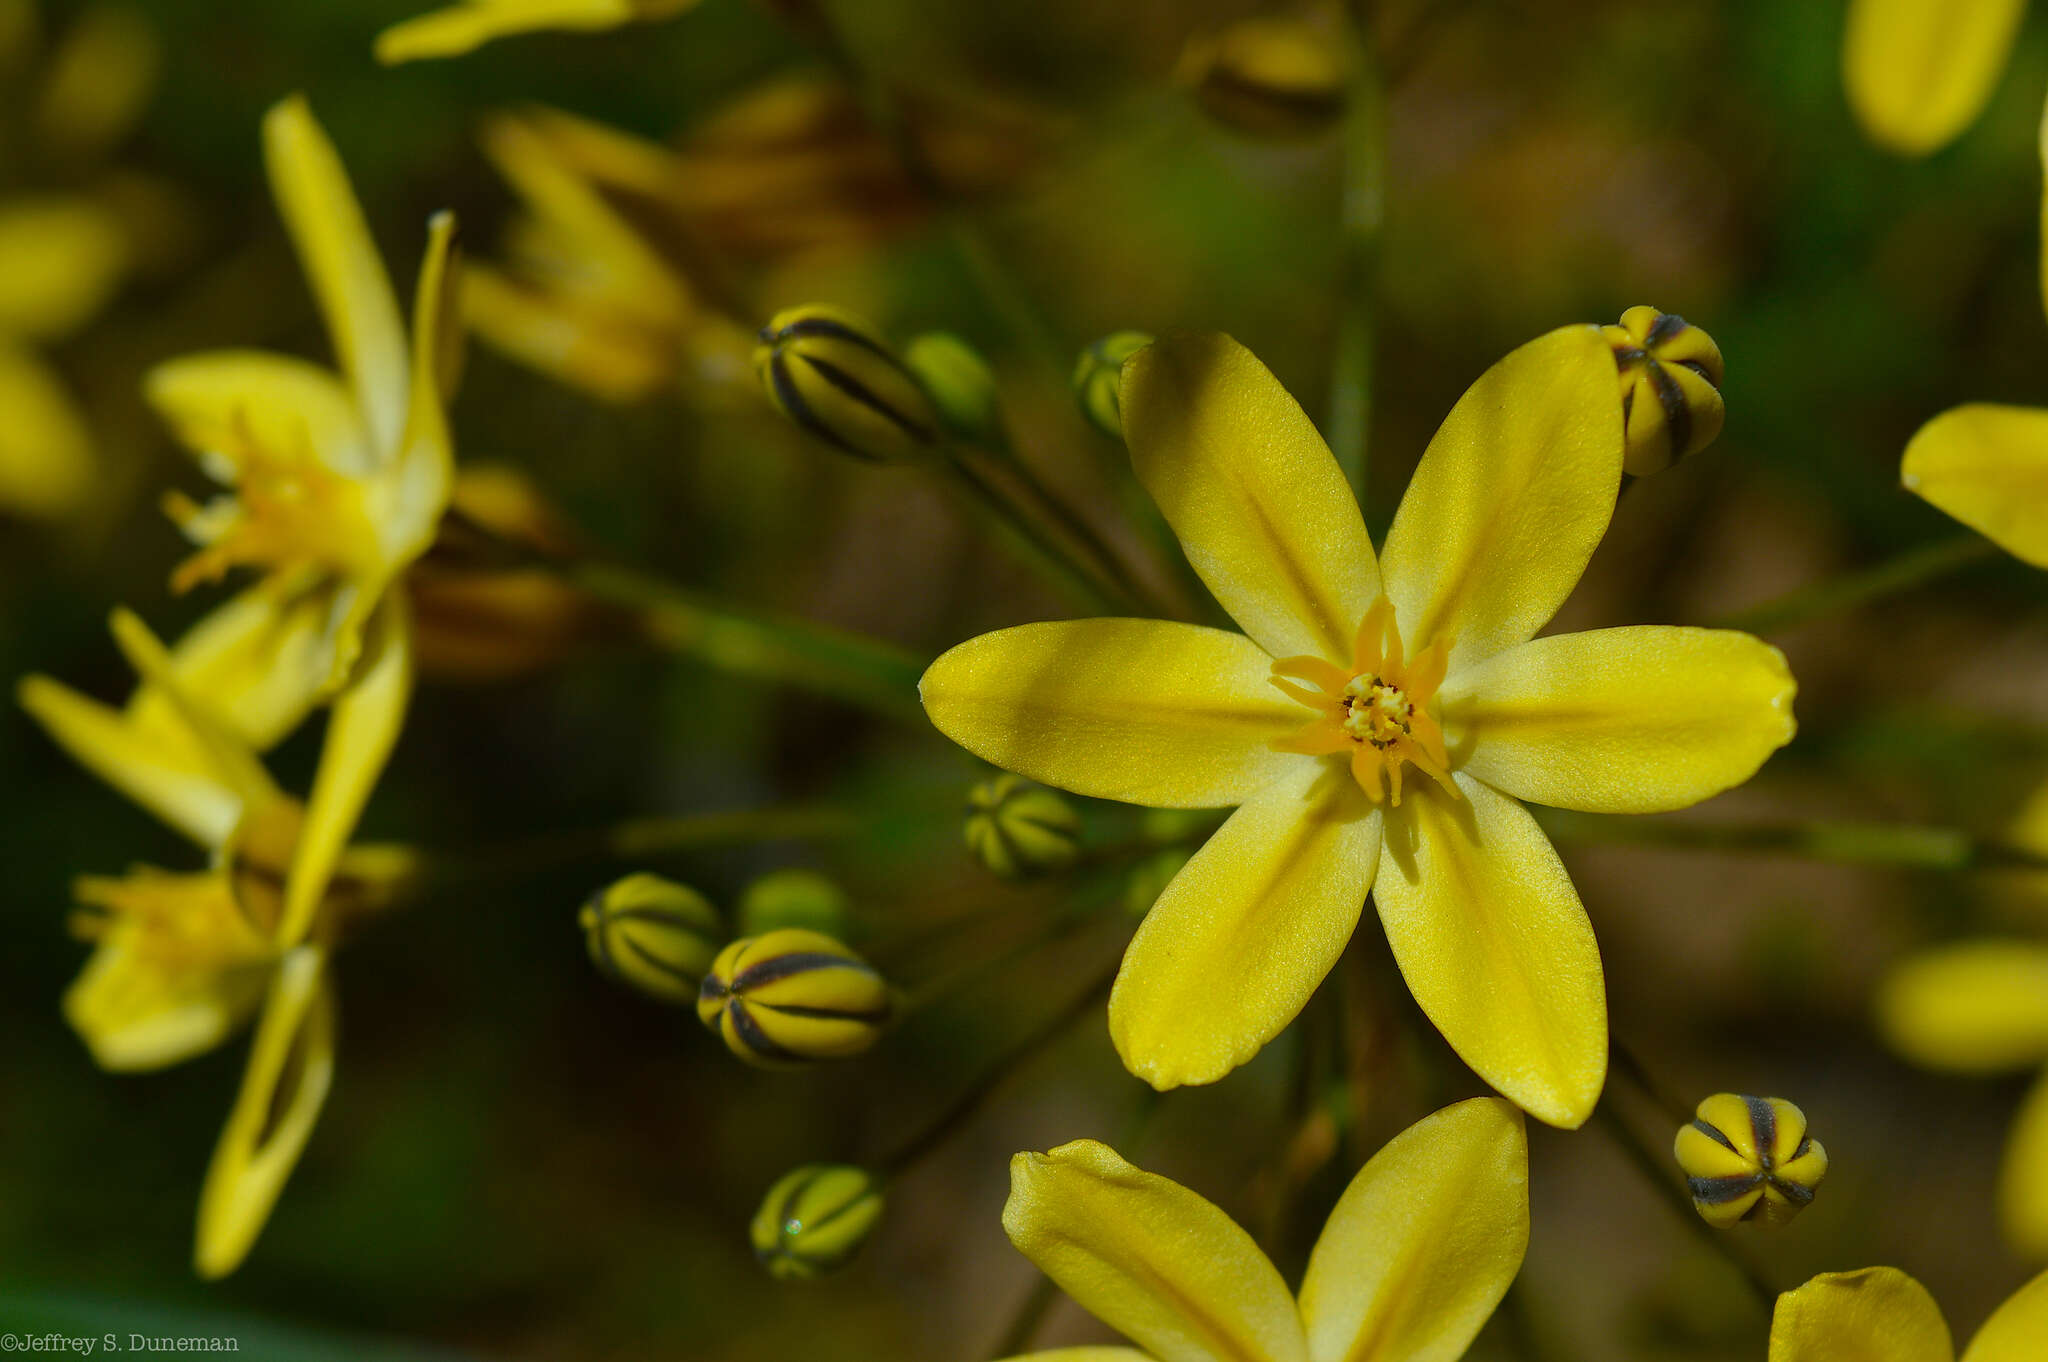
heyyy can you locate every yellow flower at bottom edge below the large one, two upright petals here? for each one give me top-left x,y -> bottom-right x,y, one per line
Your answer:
1004,1098 -> 1530,1362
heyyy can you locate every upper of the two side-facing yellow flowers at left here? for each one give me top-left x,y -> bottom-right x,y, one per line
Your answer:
147,96 -> 461,946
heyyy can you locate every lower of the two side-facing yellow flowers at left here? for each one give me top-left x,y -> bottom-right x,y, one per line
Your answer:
20,610 -> 414,1278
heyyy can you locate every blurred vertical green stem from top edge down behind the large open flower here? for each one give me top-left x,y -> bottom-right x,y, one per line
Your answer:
1329,6 -> 1386,504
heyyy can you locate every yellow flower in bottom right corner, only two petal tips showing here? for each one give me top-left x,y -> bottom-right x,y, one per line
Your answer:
1772,1268 -> 2048,1362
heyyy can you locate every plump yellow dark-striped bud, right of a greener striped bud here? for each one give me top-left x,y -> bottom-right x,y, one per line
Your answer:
696,928 -> 891,1069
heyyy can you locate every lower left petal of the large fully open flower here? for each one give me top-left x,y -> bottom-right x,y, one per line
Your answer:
1110,756 -> 1380,1090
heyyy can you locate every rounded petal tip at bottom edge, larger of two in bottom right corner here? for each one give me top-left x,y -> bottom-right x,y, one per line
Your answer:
1769,1268 -> 1956,1362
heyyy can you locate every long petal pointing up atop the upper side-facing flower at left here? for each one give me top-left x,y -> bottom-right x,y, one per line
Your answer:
262,94 -> 408,455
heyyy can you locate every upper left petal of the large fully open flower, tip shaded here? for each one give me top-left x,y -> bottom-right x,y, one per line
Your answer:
1122,334 -> 1376,662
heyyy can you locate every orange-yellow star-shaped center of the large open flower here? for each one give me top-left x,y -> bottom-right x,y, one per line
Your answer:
1272,596 -> 1458,805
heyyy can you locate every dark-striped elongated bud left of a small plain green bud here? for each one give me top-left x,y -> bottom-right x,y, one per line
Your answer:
754,307 -> 938,463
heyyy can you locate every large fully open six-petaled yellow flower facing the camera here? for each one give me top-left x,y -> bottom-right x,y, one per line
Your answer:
924,326 -> 1792,1126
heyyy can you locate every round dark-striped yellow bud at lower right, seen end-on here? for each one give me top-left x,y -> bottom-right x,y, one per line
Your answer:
1671,1092 -> 1827,1229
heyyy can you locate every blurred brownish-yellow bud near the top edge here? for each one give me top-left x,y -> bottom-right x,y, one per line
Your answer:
1182,18 -> 1350,141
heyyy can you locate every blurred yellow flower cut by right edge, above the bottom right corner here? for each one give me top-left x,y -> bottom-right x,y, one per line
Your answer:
1876,940 -> 2048,1260
